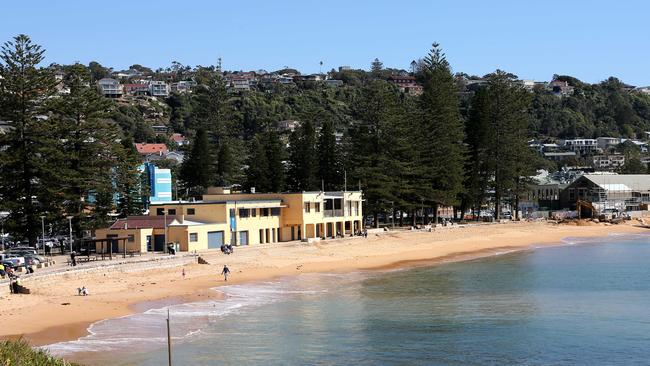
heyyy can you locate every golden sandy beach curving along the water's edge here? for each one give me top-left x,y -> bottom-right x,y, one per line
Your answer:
0,221 -> 649,345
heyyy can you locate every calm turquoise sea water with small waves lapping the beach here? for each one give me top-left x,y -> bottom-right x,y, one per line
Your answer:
51,236 -> 650,365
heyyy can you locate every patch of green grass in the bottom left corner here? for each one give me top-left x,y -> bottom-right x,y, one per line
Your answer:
0,339 -> 79,366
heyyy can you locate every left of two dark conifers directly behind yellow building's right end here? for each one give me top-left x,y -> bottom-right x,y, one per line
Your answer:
289,120 -> 320,191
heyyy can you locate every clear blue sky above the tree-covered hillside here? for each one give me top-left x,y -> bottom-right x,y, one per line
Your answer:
0,0 -> 650,86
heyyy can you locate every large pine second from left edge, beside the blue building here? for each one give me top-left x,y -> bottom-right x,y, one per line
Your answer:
50,64 -> 119,231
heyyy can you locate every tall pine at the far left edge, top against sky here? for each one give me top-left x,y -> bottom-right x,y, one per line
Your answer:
0,34 -> 60,244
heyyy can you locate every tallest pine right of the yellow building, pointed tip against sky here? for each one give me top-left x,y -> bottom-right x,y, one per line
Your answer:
416,43 -> 465,224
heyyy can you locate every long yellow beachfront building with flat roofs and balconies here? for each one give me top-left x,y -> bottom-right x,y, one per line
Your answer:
96,187 -> 363,252
